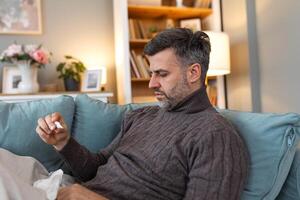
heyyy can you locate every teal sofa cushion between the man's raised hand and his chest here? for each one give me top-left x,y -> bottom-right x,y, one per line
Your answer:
72,94 -> 132,152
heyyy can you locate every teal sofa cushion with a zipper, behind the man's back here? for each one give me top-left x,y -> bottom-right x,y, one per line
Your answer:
220,110 -> 300,200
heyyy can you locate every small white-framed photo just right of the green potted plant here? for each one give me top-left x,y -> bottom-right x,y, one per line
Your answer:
80,69 -> 103,92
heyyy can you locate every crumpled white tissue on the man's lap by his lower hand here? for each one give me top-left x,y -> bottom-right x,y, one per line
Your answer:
33,169 -> 63,200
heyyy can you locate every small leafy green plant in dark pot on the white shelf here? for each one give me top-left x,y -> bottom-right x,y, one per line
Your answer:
56,55 -> 86,91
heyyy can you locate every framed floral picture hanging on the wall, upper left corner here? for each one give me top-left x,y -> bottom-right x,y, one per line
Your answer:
0,0 -> 42,34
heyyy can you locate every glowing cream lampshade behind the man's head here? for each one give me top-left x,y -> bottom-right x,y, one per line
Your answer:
205,31 -> 230,76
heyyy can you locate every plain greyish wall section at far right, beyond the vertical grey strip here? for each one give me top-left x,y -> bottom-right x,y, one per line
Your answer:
256,0 -> 300,113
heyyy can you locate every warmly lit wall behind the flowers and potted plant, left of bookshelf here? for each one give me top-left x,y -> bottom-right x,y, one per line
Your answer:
0,0 -> 116,101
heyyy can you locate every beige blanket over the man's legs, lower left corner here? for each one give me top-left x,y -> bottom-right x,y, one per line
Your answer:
0,149 -> 74,200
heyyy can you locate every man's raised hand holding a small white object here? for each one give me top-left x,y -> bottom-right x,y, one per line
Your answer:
36,112 -> 70,151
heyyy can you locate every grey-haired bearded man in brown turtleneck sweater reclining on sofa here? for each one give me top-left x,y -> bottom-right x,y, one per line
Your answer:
37,28 -> 247,200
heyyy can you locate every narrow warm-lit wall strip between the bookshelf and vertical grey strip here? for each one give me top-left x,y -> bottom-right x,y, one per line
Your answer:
222,0 -> 252,111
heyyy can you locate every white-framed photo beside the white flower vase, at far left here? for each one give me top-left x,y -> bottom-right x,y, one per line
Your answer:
2,66 -> 22,94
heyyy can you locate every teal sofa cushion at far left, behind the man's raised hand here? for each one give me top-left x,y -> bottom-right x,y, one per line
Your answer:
0,96 -> 74,171
